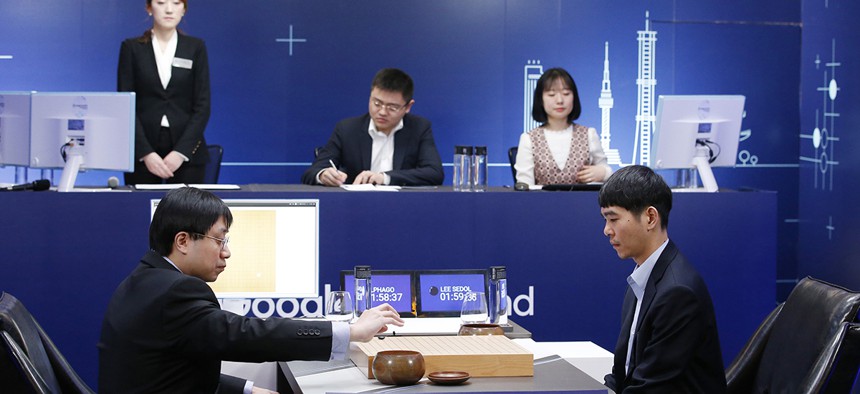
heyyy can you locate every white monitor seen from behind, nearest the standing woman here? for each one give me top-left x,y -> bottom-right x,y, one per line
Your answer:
30,92 -> 135,191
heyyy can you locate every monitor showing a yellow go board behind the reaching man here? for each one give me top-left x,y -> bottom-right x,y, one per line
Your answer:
152,199 -> 319,298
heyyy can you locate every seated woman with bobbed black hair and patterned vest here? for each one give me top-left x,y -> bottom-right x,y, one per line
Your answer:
514,68 -> 612,186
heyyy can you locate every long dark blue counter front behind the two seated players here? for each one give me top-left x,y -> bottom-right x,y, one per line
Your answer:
0,185 -> 777,388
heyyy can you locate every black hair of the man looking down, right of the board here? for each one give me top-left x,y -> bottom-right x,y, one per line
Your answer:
597,165 -> 672,230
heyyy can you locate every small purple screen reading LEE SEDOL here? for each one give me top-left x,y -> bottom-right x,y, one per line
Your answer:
416,269 -> 487,316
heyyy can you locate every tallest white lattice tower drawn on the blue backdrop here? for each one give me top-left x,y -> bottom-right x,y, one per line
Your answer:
632,11 -> 657,166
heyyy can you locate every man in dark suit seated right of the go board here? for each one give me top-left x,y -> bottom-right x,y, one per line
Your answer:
598,166 -> 726,394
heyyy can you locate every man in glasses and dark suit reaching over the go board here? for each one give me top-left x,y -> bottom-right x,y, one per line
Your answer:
98,187 -> 403,394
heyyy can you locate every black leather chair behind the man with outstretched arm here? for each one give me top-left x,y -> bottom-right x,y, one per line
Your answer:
0,293 -> 93,394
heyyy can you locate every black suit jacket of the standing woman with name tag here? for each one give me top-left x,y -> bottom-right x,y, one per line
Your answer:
117,33 -> 210,164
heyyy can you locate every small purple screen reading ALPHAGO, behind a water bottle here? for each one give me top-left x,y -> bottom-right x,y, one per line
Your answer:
340,270 -> 415,317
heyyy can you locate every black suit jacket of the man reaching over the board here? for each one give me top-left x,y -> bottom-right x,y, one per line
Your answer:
98,251 -> 332,393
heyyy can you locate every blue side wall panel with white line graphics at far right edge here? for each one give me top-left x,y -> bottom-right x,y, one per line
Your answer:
797,0 -> 860,289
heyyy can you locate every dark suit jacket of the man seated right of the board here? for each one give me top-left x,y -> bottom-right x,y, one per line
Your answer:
605,240 -> 726,393
